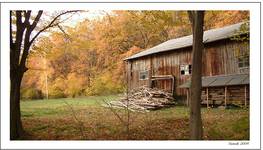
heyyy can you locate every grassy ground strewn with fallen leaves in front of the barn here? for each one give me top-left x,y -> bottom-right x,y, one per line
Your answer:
21,96 -> 249,140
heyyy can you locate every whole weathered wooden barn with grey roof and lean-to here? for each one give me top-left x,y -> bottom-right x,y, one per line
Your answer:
125,23 -> 249,105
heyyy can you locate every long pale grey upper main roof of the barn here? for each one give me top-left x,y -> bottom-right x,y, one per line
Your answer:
124,22 -> 250,60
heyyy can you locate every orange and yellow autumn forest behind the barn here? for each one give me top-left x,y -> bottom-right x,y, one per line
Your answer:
21,11 -> 249,99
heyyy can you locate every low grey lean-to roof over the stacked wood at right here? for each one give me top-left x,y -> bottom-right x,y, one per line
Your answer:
179,74 -> 249,88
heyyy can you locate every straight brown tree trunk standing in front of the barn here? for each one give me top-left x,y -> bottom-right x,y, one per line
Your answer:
188,11 -> 204,140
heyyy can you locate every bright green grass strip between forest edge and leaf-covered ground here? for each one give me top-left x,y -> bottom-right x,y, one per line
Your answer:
21,95 -> 117,117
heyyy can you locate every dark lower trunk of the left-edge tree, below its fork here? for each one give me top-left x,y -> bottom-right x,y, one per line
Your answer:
10,69 -> 23,140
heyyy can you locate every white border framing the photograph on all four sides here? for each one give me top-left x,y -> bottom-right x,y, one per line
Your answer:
1,2 -> 261,149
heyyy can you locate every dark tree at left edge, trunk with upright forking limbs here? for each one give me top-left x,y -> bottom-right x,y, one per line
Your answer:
10,10 -> 43,140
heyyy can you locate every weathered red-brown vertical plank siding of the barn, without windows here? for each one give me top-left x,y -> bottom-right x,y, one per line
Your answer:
128,39 -> 249,95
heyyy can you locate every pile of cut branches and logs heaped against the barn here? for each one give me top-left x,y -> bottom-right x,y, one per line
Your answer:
102,87 -> 175,111
